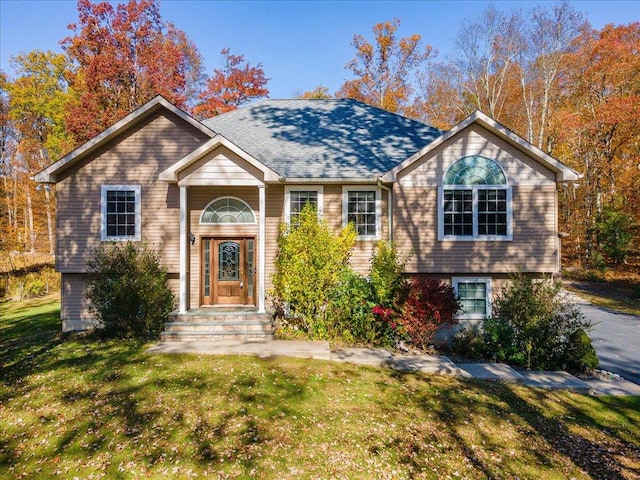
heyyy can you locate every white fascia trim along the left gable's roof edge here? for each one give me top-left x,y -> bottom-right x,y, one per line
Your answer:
32,95 -> 215,183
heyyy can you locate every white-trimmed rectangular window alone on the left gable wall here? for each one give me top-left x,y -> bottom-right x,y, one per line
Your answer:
100,185 -> 141,241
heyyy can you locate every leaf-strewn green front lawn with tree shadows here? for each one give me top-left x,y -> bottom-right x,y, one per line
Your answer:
0,297 -> 640,479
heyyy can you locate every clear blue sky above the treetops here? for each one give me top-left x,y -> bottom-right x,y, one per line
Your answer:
0,0 -> 640,98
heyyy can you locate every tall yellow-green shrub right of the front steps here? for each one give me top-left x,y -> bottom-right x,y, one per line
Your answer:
272,204 -> 357,338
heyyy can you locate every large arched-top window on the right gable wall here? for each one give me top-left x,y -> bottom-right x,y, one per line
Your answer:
438,155 -> 513,240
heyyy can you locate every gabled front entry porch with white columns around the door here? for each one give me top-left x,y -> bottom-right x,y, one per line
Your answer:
159,135 -> 280,314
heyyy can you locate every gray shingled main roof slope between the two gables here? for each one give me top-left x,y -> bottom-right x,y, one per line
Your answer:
202,99 -> 442,179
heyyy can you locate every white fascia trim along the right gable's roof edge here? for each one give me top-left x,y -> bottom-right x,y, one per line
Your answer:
382,110 -> 582,182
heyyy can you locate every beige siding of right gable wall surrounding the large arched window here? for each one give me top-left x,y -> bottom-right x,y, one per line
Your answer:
394,125 -> 559,275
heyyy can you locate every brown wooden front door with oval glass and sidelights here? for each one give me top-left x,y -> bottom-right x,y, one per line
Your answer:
201,238 -> 255,305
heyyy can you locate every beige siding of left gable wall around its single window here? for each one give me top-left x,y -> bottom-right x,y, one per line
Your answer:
56,110 -> 208,272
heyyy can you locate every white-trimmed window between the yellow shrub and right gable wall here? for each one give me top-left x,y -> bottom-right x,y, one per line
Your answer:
342,186 -> 381,239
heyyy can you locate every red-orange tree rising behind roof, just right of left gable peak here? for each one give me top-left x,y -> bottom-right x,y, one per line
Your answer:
193,48 -> 269,118
